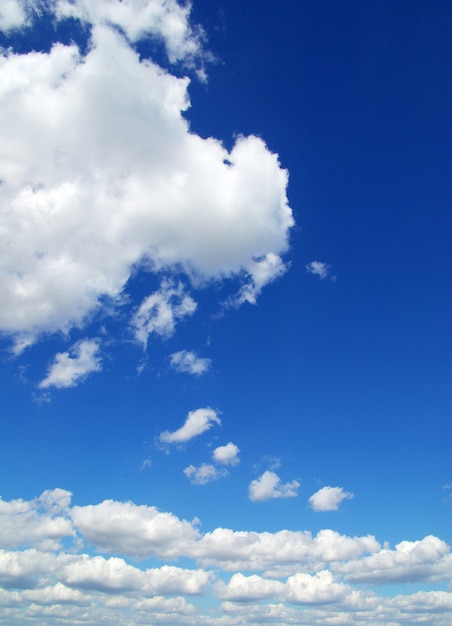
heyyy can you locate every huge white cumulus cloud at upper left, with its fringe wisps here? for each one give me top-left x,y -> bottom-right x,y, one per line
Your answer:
0,0 -> 294,352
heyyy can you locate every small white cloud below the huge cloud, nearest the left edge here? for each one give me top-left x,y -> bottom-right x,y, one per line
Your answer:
39,339 -> 102,389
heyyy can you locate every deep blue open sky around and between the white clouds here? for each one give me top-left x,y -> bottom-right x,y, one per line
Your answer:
0,0 -> 452,626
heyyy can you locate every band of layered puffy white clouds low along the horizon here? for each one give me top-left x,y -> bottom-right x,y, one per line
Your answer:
0,489 -> 452,626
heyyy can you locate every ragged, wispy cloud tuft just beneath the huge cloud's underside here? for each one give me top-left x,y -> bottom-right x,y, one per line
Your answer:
132,280 -> 196,348
